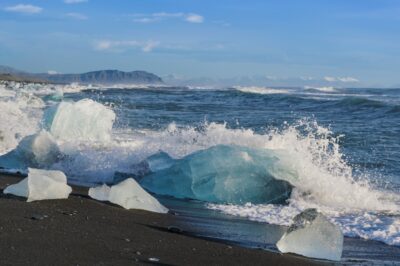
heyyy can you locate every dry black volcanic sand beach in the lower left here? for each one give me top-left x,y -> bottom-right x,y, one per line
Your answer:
0,175 -> 328,265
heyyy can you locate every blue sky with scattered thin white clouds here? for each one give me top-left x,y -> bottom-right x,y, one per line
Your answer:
0,0 -> 400,87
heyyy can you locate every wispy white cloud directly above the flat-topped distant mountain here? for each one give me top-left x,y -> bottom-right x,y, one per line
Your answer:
94,40 -> 160,53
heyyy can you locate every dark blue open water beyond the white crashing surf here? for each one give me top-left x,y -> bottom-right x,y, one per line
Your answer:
66,88 -> 400,186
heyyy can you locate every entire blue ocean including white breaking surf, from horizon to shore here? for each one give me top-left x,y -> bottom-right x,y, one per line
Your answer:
0,82 -> 400,263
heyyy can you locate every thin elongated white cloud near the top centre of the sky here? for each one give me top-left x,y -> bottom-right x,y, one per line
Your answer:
133,12 -> 204,23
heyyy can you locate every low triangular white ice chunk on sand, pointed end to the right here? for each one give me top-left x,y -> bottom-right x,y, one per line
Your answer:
89,178 -> 168,213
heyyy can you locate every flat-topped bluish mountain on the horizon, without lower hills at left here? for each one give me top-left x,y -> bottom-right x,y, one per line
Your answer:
38,70 -> 163,85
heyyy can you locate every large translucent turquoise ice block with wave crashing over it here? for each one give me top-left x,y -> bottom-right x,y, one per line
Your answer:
140,145 -> 296,204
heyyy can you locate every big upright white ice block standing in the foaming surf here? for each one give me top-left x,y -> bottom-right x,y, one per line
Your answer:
45,99 -> 115,141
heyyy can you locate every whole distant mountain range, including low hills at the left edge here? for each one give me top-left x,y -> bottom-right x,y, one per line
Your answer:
0,66 -> 163,85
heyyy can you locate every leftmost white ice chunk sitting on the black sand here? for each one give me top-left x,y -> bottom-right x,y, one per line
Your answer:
4,168 -> 72,202
